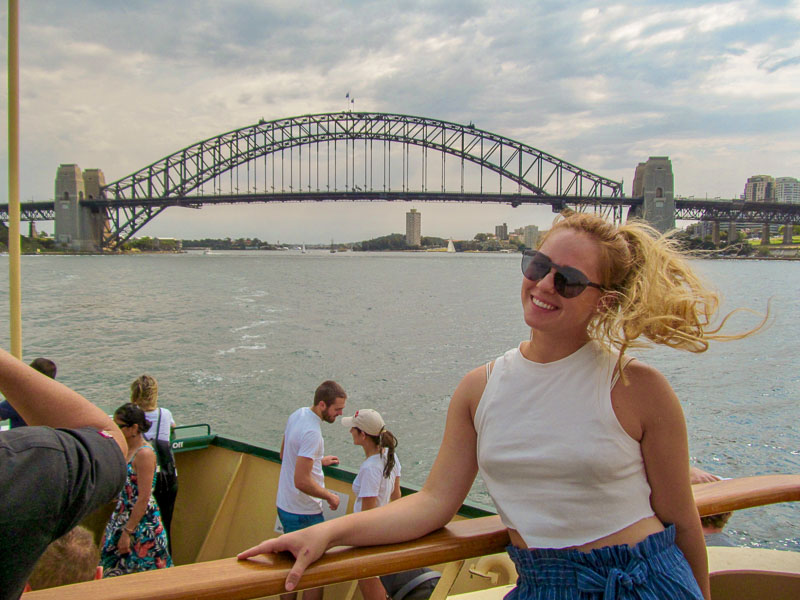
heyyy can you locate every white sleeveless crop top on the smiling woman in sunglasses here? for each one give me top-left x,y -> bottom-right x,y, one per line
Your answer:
475,342 -> 654,548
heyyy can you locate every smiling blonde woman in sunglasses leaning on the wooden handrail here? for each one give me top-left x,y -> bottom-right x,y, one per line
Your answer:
239,213 -> 764,600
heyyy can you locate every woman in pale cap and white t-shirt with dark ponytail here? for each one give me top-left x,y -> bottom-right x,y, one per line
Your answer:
342,408 -> 400,600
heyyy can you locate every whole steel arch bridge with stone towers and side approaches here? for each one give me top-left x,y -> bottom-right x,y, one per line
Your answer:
0,112 -> 800,251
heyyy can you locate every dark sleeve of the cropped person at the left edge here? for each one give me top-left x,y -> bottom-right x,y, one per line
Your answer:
0,427 -> 125,600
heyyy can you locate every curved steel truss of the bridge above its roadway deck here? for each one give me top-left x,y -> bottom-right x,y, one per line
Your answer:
100,112 -> 622,247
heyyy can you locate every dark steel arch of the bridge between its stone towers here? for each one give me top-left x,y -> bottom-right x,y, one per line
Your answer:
101,112 -> 622,245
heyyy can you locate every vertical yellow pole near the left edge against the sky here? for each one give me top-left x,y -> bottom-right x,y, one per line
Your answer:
8,0 -> 22,359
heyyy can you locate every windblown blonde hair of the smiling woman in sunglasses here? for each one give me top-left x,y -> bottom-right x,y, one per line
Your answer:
541,212 -> 769,376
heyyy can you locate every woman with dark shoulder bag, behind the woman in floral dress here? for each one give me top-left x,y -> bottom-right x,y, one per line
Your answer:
131,375 -> 178,552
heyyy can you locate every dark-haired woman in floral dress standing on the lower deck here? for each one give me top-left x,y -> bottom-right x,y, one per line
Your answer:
100,403 -> 172,577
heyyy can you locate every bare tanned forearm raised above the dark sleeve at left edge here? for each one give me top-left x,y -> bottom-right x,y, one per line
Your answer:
0,350 -> 128,455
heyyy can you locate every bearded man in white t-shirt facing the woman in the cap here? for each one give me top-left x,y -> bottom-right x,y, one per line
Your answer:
276,381 -> 347,600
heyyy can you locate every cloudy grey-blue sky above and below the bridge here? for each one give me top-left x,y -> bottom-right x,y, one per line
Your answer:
0,0 -> 800,243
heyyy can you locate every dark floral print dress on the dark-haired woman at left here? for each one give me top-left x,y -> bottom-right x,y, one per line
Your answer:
100,446 -> 172,577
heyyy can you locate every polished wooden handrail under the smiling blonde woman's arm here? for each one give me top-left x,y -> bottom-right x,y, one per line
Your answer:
24,475 -> 800,600
